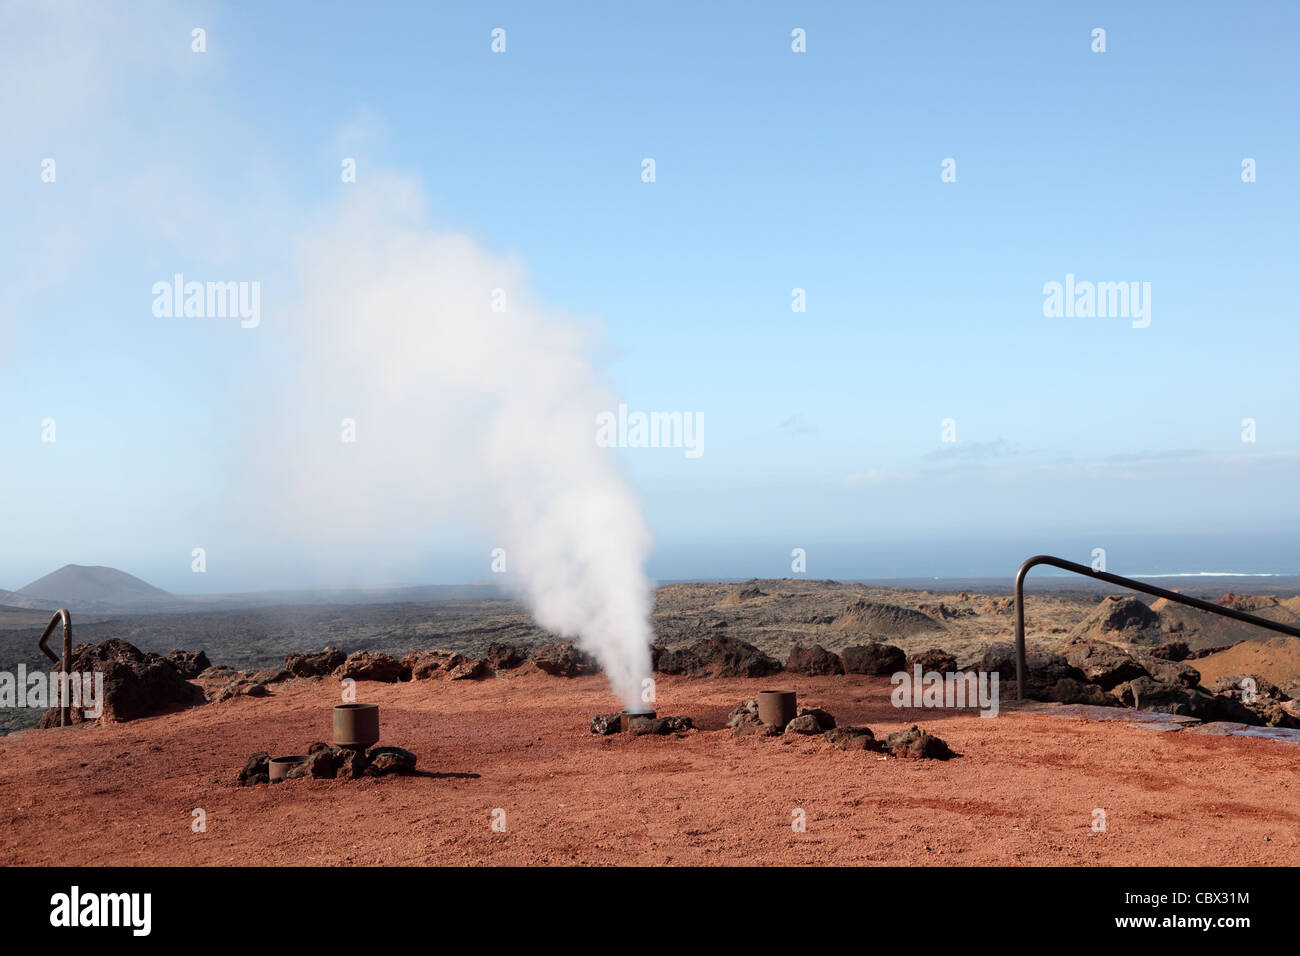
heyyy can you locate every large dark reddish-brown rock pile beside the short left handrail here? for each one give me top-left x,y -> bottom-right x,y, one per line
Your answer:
36,637 -> 204,727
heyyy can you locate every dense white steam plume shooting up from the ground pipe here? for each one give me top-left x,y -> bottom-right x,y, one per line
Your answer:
263,174 -> 651,706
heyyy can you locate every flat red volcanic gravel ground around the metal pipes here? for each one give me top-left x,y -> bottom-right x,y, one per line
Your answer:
0,672 -> 1300,865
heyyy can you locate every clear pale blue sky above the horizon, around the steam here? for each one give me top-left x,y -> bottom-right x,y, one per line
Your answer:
0,3 -> 1300,592
